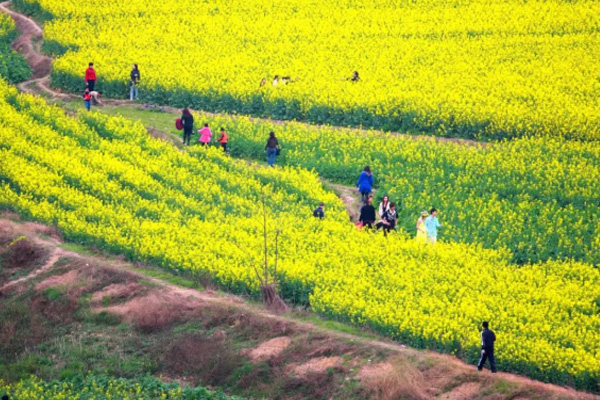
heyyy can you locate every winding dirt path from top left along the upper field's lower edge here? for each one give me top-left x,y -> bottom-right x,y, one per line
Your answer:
0,1 -> 487,147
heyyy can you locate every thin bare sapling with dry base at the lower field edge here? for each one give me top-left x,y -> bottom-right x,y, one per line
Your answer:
236,195 -> 289,313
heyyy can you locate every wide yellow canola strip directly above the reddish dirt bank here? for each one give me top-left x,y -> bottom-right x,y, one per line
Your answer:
0,82 -> 600,392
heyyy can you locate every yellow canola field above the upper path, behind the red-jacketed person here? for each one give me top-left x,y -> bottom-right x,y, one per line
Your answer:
14,0 -> 600,141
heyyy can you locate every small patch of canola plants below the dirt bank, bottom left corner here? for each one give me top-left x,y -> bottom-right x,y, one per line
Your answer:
0,375 -> 243,400
